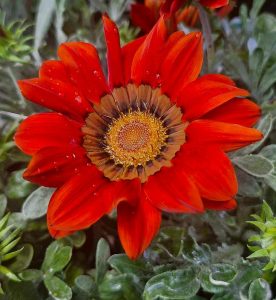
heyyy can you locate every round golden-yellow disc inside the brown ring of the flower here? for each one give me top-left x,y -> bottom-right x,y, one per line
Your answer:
105,111 -> 167,167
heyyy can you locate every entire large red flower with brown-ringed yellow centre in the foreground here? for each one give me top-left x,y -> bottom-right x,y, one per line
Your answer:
15,16 -> 262,258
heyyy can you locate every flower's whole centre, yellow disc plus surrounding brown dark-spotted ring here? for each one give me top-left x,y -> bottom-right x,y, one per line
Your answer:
82,84 -> 187,182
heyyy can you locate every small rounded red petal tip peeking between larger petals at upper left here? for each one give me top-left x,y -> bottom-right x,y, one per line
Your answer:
39,60 -> 70,82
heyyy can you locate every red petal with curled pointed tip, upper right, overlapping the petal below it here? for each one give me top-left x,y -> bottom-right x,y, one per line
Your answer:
177,75 -> 249,120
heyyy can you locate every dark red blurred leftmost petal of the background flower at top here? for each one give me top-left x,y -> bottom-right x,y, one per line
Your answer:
130,3 -> 157,33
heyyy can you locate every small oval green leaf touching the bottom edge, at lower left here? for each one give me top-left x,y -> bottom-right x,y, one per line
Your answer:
44,276 -> 72,300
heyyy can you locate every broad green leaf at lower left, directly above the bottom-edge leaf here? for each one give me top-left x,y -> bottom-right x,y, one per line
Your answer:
42,241 -> 72,274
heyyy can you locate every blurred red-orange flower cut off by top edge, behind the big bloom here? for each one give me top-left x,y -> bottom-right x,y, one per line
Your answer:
131,0 -> 229,33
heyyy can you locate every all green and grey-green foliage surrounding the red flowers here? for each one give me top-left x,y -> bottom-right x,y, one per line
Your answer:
0,0 -> 276,300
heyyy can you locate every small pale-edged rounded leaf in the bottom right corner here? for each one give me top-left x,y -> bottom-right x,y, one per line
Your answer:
248,278 -> 272,300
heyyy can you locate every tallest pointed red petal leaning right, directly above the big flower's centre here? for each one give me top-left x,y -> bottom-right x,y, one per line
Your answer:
131,17 -> 167,87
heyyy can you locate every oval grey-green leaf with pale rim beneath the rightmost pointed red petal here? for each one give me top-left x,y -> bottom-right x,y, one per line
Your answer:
233,154 -> 274,177
